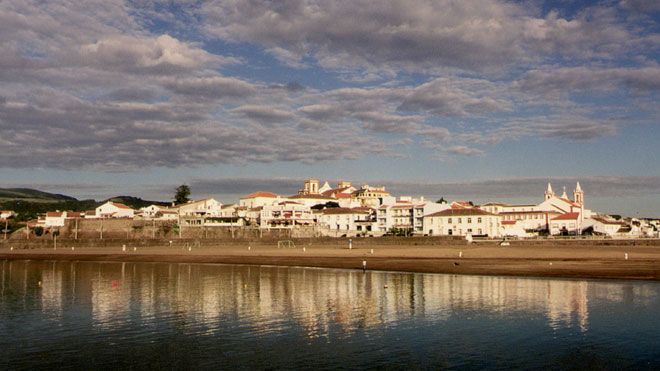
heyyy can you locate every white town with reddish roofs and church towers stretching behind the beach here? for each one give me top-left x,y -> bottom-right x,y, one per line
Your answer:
0,178 -> 660,239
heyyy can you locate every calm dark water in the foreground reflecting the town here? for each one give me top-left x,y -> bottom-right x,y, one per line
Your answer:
0,261 -> 660,369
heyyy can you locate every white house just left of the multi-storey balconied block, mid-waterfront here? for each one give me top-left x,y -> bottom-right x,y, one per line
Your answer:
318,207 -> 373,236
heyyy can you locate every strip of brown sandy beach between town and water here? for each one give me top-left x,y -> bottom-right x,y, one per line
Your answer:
0,243 -> 660,280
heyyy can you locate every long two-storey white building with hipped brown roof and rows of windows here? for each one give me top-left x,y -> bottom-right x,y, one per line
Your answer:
424,208 -> 501,237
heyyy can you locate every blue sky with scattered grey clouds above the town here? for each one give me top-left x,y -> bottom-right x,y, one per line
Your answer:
0,0 -> 660,217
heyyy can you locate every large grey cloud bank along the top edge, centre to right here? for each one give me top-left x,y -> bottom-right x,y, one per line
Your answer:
201,0 -> 643,72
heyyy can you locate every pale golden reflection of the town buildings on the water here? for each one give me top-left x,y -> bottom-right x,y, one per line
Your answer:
0,261 -> 657,338
